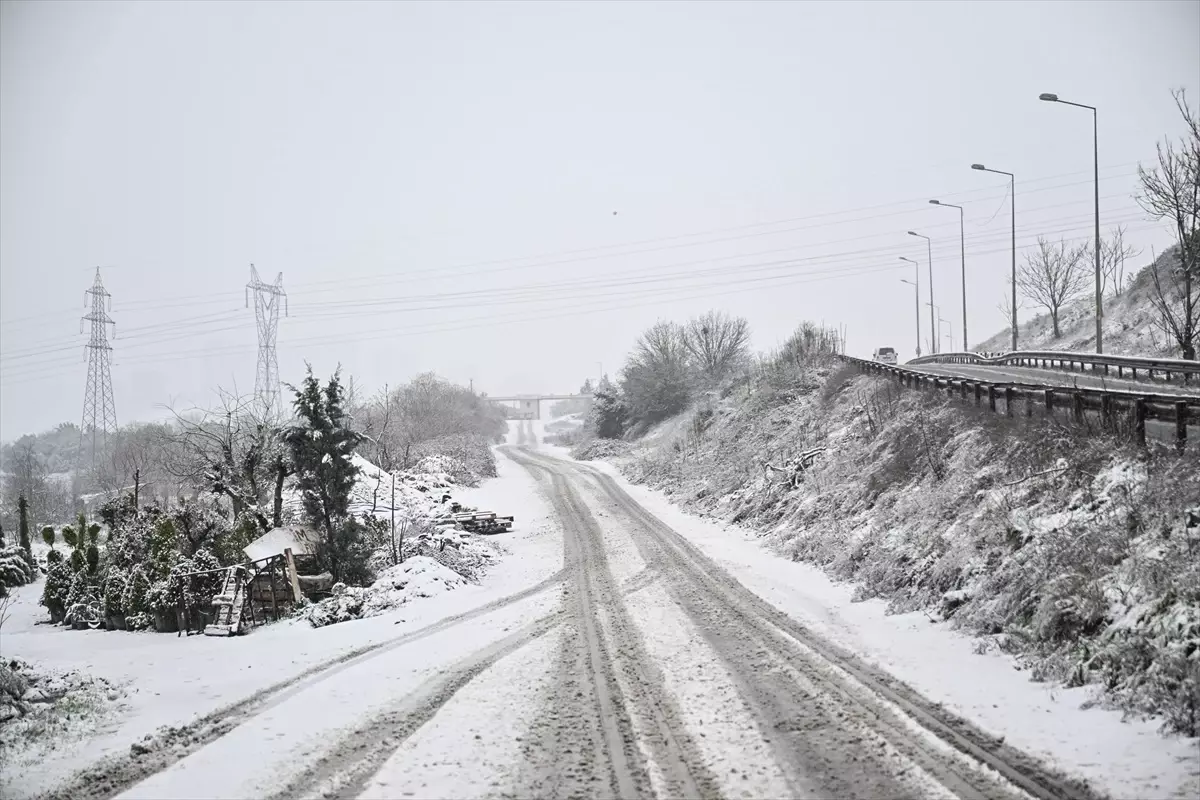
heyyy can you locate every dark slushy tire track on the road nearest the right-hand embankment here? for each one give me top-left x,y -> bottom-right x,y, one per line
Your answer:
535,448 -> 1098,800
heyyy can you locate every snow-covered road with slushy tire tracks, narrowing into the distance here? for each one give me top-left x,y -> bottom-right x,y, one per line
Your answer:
11,423 -> 1195,800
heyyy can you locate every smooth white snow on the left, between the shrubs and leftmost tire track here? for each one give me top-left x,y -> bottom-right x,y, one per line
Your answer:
0,431 -> 563,800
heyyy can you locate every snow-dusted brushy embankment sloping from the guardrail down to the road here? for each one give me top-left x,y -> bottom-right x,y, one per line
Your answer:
577,367 -> 1200,735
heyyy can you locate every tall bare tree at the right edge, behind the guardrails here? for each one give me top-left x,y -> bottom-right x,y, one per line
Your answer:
1138,89 -> 1200,360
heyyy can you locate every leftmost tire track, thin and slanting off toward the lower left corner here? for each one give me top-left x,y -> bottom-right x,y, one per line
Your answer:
38,570 -> 566,800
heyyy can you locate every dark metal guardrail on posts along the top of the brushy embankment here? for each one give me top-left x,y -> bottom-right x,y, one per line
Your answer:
838,354 -> 1200,452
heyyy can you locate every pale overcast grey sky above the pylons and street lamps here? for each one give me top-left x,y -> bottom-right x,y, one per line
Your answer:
0,0 -> 1200,440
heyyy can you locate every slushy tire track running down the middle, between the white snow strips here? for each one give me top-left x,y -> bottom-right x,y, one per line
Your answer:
503,447 -> 720,798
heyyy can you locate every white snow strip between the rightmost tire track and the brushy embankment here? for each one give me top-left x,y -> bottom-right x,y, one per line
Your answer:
566,431 -> 1200,800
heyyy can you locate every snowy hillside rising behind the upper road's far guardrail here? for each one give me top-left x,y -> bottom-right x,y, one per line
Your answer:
973,248 -> 1180,357
